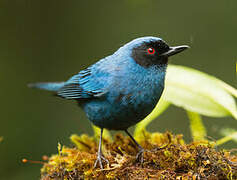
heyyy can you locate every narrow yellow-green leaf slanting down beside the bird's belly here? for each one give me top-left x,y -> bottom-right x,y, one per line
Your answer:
134,96 -> 170,140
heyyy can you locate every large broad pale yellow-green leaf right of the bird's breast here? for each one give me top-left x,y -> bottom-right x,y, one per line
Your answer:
164,65 -> 237,119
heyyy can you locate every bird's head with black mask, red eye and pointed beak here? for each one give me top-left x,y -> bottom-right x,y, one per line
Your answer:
121,37 -> 189,67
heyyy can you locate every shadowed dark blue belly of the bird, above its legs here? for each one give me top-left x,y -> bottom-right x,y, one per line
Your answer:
83,89 -> 163,130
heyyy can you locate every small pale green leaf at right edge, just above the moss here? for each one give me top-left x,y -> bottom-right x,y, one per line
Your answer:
216,128 -> 237,146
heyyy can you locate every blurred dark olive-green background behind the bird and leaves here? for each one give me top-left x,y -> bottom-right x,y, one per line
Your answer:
0,0 -> 237,180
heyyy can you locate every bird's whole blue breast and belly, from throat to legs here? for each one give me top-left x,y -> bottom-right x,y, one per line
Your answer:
84,64 -> 165,130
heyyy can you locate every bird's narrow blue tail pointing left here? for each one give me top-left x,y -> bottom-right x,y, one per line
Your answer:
28,82 -> 65,91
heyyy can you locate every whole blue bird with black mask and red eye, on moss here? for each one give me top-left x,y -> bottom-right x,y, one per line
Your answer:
29,37 -> 188,169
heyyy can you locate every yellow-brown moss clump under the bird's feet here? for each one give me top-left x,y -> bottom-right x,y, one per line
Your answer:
41,132 -> 237,180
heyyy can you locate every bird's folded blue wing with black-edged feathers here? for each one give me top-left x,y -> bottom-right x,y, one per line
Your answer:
57,68 -> 106,99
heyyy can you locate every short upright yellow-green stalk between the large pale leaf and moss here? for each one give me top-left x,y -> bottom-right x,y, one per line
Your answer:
187,111 -> 207,141
